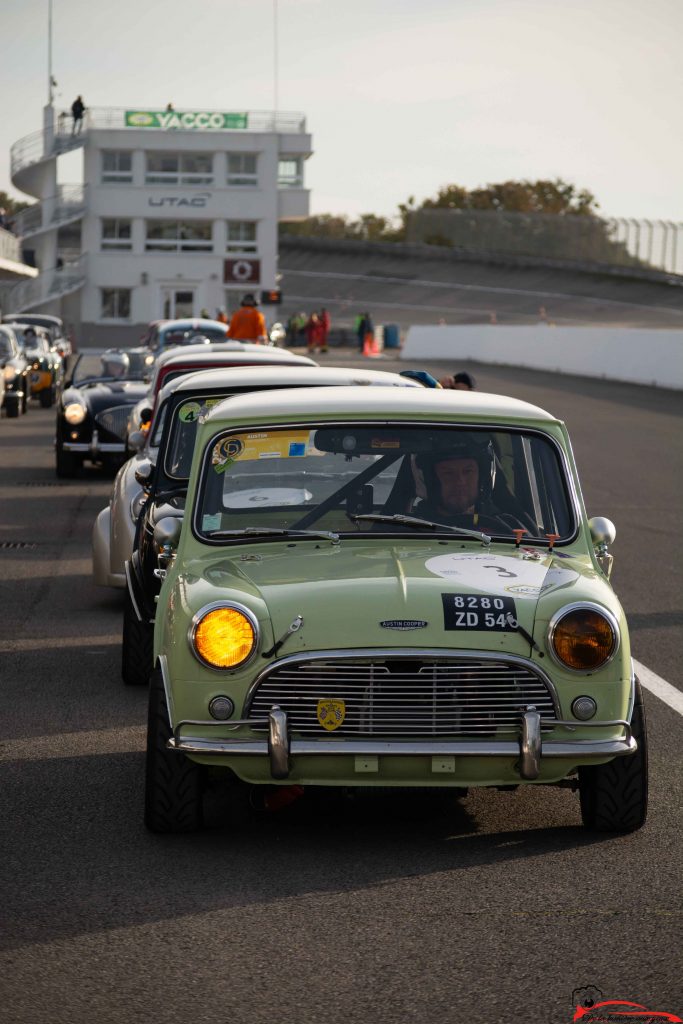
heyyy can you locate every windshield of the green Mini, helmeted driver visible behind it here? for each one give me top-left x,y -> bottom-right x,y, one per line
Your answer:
194,423 -> 575,544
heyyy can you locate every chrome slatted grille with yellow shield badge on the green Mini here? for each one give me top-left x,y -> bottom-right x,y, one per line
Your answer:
247,656 -> 556,737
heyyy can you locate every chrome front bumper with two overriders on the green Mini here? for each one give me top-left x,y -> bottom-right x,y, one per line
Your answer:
168,705 -> 638,780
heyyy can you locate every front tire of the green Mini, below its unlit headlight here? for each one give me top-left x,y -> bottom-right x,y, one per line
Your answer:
579,680 -> 647,833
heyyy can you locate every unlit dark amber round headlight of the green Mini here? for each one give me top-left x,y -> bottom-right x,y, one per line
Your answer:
548,604 -> 620,672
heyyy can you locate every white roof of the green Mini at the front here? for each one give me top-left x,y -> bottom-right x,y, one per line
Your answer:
201,387 -> 559,429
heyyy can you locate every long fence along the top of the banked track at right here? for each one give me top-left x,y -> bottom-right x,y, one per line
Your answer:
407,209 -> 683,274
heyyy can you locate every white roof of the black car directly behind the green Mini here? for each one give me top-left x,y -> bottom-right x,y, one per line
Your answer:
162,365 -> 422,397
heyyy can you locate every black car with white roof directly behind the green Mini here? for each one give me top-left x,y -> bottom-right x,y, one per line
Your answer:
116,366 -> 420,686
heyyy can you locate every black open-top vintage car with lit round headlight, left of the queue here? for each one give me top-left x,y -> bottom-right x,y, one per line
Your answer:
55,349 -> 151,477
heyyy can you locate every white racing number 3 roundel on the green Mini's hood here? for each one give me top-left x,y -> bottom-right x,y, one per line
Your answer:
425,554 -> 547,598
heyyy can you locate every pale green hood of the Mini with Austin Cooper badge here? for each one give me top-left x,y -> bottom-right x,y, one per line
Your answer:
182,539 -> 607,655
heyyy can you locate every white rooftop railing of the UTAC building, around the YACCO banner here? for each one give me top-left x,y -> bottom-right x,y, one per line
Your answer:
10,106 -> 306,178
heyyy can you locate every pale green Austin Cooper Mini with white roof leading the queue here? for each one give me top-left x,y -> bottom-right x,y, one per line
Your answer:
145,387 -> 647,833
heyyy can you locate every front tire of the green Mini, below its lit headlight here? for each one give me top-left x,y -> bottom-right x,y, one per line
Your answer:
144,670 -> 206,834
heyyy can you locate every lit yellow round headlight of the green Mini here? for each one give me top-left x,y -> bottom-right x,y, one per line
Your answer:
189,604 -> 259,669
